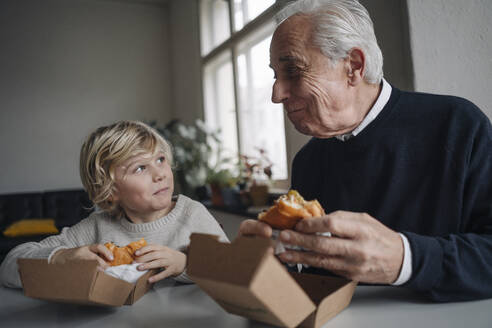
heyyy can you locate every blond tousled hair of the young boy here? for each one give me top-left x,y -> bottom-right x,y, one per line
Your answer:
80,121 -> 173,216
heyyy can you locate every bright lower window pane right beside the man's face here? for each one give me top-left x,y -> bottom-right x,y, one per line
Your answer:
238,29 -> 287,180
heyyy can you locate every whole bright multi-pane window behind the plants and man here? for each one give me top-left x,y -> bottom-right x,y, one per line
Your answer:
200,0 -> 287,180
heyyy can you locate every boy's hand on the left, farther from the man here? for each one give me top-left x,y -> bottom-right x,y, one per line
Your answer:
51,244 -> 113,269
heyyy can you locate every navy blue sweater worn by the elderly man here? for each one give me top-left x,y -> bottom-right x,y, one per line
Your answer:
292,88 -> 492,301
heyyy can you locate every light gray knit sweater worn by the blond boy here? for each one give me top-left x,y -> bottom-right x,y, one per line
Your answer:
0,195 -> 228,288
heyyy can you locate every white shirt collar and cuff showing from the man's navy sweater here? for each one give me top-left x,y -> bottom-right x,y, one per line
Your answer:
335,79 -> 412,286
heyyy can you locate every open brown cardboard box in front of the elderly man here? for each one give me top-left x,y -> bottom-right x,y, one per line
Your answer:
187,234 -> 357,328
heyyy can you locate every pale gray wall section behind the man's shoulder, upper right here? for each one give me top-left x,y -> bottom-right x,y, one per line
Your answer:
407,0 -> 492,118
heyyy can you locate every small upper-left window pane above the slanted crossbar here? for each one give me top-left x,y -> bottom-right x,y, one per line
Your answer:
200,0 -> 231,55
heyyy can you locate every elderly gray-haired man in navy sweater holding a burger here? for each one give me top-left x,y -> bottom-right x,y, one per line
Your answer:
240,0 -> 492,301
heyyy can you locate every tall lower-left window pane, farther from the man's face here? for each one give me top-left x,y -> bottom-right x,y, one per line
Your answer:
204,52 -> 238,168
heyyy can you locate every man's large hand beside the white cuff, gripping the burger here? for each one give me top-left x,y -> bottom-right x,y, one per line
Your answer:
279,211 -> 404,284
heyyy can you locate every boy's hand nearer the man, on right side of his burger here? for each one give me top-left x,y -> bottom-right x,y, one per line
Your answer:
135,244 -> 186,283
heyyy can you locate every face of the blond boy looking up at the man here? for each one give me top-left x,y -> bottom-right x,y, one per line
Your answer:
113,151 -> 174,223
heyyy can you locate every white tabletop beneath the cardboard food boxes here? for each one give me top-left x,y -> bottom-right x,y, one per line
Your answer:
0,281 -> 492,328
